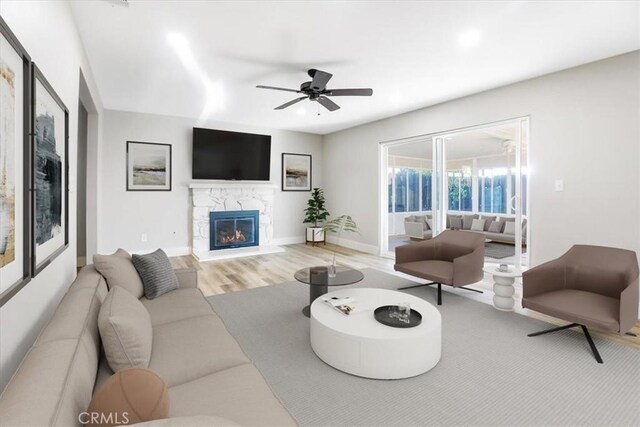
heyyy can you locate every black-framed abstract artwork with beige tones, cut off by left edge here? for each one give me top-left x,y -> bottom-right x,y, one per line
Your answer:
0,18 -> 31,306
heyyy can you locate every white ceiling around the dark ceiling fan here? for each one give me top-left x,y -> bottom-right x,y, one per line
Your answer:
71,0 -> 640,134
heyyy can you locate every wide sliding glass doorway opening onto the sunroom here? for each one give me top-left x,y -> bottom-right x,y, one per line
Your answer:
380,118 -> 530,268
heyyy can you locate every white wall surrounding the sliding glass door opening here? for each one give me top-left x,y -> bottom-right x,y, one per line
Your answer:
323,51 -> 640,265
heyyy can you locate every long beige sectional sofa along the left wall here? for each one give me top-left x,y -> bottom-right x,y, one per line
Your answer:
0,266 -> 296,426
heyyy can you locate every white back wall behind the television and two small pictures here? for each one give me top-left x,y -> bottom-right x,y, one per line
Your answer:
99,110 -> 323,255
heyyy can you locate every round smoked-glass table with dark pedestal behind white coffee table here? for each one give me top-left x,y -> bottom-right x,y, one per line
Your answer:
293,266 -> 364,317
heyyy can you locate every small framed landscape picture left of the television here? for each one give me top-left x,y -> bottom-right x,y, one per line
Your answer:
127,141 -> 171,191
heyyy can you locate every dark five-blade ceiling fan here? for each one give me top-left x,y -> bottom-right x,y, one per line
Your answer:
256,68 -> 373,111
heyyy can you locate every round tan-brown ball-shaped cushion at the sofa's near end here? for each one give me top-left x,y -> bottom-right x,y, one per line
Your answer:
89,367 -> 169,426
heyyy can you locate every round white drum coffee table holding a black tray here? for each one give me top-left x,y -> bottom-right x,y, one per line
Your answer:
310,288 -> 442,379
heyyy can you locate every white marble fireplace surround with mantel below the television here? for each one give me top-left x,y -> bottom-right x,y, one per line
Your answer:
189,181 -> 283,261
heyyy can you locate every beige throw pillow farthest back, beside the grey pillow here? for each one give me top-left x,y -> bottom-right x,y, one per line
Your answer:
93,249 -> 144,298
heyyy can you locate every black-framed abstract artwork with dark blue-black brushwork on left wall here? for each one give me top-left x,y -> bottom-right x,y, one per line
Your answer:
32,64 -> 69,276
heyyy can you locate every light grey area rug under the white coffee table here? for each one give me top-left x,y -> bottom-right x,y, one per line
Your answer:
209,269 -> 640,426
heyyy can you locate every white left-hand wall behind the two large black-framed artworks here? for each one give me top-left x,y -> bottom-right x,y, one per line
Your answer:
0,0 -> 102,389
